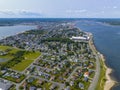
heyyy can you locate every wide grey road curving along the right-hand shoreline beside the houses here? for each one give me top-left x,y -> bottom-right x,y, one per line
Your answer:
88,35 -> 100,90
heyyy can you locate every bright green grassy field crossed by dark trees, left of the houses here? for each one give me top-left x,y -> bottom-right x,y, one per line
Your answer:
0,46 -> 40,71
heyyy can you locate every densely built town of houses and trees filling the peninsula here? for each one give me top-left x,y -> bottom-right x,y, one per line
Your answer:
0,22 -> 96,90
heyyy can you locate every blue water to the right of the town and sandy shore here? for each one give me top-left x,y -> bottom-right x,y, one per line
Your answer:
76,20 -> 120,90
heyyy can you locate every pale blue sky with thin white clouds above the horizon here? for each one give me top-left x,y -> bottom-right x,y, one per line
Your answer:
0,0 -> 120,18
